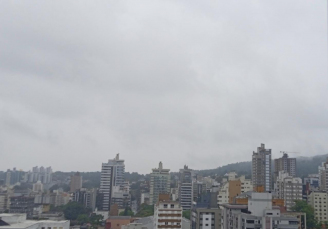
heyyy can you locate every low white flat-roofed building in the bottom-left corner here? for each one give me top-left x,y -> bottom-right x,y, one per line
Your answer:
0,214 -> 70,229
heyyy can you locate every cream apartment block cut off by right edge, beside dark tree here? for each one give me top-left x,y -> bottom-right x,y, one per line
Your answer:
307,191 -> 328,222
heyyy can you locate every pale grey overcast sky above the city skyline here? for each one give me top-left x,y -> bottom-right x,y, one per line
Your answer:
0,0 -> 328,173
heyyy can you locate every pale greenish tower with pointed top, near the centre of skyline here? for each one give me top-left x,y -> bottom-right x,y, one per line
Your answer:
149,162 -> 171,205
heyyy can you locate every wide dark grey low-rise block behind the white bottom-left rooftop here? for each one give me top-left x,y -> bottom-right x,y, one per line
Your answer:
9,196 -> 34,218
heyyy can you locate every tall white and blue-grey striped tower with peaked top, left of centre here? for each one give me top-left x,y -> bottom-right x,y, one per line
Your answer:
98,154 -> 125,211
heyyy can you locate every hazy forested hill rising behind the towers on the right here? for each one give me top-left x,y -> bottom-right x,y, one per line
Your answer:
199,154 -> 328,178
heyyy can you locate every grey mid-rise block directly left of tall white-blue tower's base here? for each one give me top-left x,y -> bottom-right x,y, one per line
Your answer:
72,188 -> 97,211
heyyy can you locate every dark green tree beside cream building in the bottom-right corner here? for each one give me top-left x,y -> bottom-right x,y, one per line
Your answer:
292,200 -> 321,229
